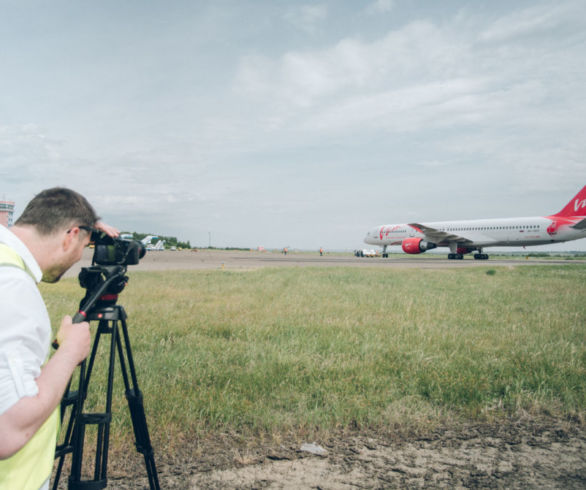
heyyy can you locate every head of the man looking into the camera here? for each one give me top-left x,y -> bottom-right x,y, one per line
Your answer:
13,187 -> 99,282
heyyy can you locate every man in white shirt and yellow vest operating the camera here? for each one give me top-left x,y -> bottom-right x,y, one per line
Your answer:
0,188 -> 118,490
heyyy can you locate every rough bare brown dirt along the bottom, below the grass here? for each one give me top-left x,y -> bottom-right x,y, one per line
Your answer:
109,420 -> 586,490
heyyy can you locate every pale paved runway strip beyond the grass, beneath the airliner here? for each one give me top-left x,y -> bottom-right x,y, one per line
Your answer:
66,249 -> 586,277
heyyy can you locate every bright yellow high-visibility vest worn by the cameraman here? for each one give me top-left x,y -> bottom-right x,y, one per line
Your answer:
0,243 -> 59,490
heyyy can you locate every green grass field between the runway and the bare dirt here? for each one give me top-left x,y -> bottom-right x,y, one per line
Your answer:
42,265 -> 586,451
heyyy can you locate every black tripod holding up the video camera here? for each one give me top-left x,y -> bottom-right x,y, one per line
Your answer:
53,267 -> 160,490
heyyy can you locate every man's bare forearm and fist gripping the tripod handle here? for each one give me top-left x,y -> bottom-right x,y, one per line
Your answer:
0,316 -> 91,459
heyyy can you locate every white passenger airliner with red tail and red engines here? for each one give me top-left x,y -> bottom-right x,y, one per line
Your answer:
364,186 -> 586,260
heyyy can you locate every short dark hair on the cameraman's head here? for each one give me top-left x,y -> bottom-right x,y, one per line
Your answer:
14,187 -> 100,235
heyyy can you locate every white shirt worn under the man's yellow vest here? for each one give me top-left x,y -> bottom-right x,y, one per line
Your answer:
0,225 -> 51,414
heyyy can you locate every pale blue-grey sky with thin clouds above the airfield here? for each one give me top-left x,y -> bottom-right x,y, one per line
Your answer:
0,0 -> 586,250
